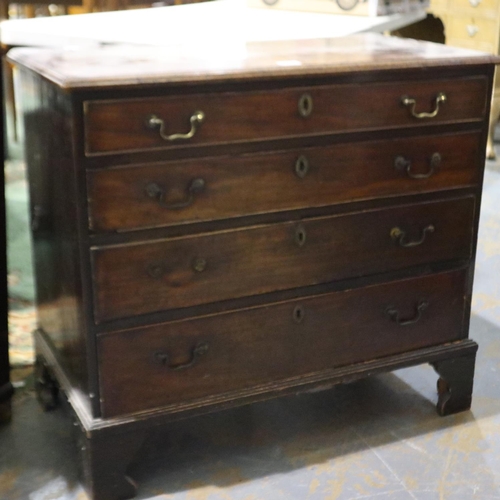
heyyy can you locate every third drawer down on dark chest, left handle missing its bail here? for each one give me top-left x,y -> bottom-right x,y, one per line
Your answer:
91,197 -> 474,322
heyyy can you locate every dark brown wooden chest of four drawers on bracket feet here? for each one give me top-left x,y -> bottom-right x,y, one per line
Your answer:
6,35 -> 496,500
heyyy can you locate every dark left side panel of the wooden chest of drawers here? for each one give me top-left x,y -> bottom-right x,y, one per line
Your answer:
23,69 -> 93,406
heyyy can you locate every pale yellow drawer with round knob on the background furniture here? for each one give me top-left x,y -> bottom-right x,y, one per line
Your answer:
446,15 -> 499,46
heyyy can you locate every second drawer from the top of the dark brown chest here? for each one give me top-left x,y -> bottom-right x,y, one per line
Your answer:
87,133 -> 482,231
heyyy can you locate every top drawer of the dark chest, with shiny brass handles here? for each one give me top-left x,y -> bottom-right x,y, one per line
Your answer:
84,77 -> 487,155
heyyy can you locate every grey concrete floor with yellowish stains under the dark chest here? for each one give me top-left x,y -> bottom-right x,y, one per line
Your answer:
0,162 -> 500,500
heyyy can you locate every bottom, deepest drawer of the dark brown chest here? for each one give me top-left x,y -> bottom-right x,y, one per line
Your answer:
98,271 -> 466,417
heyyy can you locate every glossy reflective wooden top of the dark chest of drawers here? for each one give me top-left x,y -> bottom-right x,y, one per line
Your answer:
8,33 -> 500,89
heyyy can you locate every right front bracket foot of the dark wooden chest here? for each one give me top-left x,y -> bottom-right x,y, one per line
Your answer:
432,354 -> 476,416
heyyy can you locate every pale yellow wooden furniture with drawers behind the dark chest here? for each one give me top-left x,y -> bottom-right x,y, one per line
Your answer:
429,0 -> 500,159
